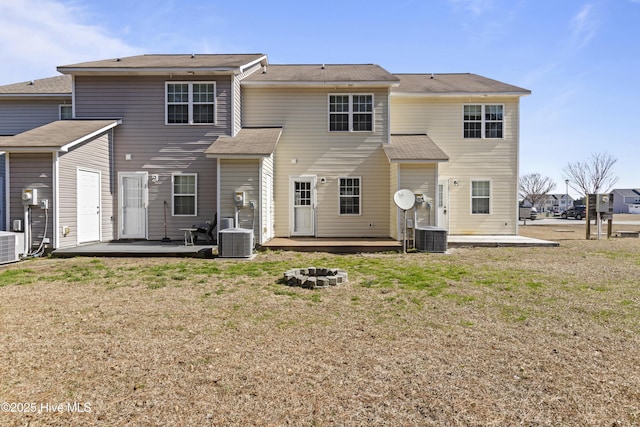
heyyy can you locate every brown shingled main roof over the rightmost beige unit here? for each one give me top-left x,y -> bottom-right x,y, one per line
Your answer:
391,73 -> 531,96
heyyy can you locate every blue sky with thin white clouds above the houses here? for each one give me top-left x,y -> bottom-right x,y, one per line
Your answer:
0,0 -> 640,195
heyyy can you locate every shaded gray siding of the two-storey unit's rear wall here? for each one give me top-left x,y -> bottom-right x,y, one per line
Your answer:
75,76 -> 226,240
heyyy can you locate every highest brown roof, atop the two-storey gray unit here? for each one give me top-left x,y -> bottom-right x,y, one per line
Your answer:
58,53 -> 267,74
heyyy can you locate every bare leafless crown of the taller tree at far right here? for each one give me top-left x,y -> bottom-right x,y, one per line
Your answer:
563,153 -> 618,196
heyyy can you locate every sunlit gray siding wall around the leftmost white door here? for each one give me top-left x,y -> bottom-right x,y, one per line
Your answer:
57,131 -> 117,248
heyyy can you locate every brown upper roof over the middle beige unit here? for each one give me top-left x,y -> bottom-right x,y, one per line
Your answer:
241,64 -> 399,86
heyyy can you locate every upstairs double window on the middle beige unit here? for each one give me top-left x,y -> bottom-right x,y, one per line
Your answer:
329,94 -> 373,132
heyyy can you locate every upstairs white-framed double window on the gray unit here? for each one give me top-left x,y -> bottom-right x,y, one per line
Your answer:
166,82 -> 216,124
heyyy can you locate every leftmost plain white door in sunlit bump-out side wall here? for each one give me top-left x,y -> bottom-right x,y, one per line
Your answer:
77,169 -> 100,243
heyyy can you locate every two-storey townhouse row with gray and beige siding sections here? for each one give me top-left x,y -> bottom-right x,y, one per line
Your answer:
0,54 -> 530,254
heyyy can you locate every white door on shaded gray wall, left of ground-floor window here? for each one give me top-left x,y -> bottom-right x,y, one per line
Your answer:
119,172 -> 147,239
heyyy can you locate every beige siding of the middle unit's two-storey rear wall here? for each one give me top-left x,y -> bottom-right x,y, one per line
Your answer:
243,87 -> 390,237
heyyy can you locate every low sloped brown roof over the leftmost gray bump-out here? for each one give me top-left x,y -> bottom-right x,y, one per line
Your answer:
0,119 -> 122,152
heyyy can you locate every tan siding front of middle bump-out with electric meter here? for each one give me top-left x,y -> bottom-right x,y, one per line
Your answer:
220,159 -> 260,240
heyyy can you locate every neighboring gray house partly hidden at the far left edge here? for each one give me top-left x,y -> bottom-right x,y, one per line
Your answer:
0,76 -> 72,230
